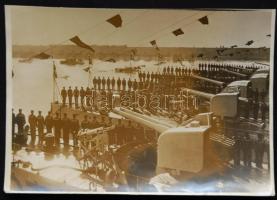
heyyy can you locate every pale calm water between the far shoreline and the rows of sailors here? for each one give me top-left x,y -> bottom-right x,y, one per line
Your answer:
12,59 -> 266,115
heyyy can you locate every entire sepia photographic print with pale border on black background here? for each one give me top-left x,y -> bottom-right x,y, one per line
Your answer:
4,5 -> 275,196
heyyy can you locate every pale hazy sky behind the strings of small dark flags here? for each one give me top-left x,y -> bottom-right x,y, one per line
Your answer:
6,6 -> 272,47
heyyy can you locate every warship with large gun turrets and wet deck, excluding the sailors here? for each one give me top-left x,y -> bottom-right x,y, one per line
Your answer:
11,58 -> 269,193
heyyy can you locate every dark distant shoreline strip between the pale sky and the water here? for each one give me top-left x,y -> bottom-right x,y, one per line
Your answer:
12,45 -> 270,62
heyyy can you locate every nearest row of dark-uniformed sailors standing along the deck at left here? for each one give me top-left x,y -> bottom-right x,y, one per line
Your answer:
12,109 -> 149,148
